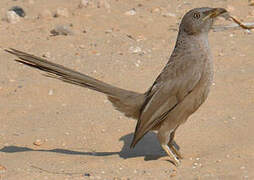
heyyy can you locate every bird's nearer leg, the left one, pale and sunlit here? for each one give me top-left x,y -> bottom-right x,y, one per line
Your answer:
157,131 -> 180,166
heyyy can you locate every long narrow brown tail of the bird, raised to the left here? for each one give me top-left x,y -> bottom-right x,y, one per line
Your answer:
5,48 -> 145,119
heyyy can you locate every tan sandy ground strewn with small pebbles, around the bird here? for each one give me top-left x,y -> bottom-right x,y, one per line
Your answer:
0,0 -> 254,180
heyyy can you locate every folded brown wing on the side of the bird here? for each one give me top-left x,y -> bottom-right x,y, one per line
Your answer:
131,58 -> 202,147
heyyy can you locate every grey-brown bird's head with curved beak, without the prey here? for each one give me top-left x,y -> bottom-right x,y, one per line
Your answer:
180,7 -> 227,35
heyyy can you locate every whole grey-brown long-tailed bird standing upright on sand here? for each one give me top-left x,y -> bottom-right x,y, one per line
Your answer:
5,7 -> 227,166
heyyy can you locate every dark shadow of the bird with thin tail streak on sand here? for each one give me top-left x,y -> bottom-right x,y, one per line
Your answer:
0,132 -> 166,161
